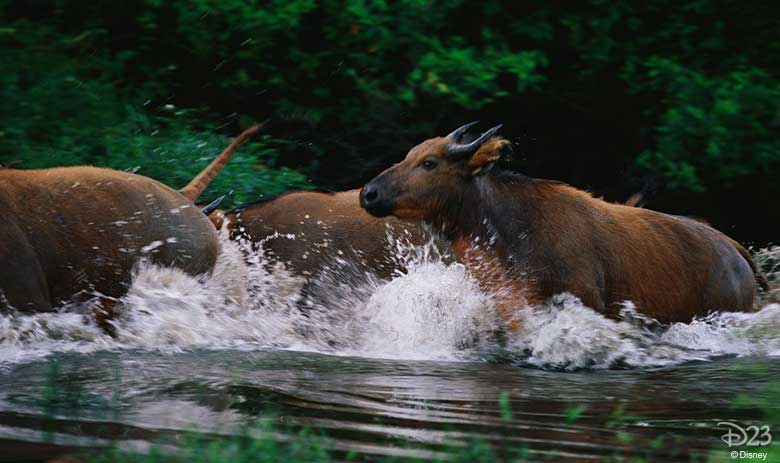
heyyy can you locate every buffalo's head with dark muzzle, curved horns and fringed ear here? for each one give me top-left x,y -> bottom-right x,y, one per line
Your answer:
360,122 -> 509,220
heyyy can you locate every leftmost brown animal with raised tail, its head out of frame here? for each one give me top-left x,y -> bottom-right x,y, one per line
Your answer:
0,126 -> 259,321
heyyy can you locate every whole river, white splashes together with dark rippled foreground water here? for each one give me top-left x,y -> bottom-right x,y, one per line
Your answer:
0,237 -> 780,462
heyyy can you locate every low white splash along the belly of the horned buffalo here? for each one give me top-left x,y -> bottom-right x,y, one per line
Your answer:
510,295 -> 780,369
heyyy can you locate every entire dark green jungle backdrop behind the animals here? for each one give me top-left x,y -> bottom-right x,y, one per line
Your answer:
0,0 -> 780,245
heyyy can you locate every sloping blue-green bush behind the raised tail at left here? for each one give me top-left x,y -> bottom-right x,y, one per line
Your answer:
0,23 -> 310,204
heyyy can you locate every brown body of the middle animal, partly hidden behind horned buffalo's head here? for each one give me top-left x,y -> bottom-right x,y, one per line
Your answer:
209,190 -> 425,278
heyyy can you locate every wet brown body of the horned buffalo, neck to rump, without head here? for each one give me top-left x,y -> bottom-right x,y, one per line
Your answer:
456,173 -> 755,322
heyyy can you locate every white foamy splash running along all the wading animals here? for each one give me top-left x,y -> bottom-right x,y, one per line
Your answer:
0,232 -> 780,369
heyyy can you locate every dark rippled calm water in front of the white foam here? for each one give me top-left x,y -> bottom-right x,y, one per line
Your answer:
0,350 -> 780,461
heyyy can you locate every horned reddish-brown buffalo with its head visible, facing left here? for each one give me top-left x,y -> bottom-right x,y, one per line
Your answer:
360,123 -> 767,323
